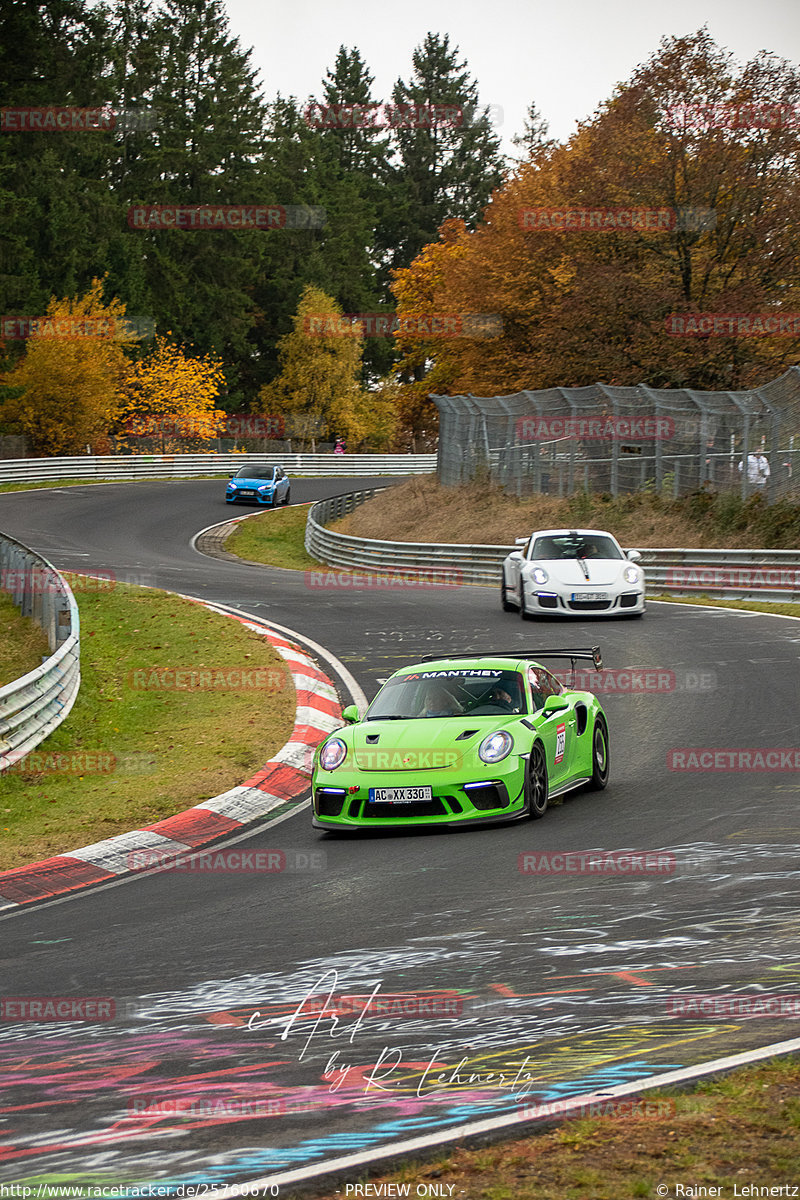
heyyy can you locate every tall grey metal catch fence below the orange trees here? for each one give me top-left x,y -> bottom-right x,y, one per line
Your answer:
431,366 -> 800,502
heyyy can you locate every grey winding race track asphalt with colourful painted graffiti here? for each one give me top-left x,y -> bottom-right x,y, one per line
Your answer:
0,479 -> 800,1195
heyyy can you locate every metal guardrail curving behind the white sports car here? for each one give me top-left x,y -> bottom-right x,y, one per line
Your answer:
306,488 -> 800,602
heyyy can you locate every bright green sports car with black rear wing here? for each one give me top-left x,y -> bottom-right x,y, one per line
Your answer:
312,646 -> 609,830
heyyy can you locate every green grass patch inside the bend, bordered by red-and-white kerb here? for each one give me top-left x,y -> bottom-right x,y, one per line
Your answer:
0,574 -> 295,869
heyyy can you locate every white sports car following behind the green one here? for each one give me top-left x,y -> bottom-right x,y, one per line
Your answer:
500,529 -> 644,620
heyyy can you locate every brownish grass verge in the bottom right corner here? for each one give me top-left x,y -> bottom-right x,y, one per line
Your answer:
298,1058 -> 800,1200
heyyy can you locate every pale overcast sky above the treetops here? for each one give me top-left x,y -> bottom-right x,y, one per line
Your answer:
227,0 -> 800,154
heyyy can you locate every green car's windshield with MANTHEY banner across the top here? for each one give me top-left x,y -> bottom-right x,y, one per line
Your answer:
366,667 -> 528,721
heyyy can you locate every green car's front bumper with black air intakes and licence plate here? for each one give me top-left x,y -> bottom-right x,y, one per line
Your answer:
312,752 -> 528,829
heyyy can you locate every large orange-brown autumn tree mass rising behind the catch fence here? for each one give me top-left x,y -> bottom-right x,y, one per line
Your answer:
393,30 -> 800,409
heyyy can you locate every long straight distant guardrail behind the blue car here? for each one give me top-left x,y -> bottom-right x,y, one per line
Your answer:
0,454 -> 437,484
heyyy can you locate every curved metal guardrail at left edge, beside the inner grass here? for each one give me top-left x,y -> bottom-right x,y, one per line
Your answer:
0,534 -> 80,773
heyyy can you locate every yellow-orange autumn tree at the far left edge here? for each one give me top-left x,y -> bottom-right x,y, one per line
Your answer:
0,280 -> 133,455
